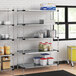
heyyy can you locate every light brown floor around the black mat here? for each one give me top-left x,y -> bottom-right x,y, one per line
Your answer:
0,64 -> 76,76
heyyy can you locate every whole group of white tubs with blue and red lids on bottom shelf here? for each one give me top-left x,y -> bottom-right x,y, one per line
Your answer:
33,53 -> 54,66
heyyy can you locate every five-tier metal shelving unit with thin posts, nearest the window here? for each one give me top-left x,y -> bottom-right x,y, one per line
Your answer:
17,9 -> 59,69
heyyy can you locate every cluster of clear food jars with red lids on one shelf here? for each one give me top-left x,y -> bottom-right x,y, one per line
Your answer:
39,42 -> 52,52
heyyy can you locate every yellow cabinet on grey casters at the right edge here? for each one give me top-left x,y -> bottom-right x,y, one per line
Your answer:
67,46 -> 76,66
